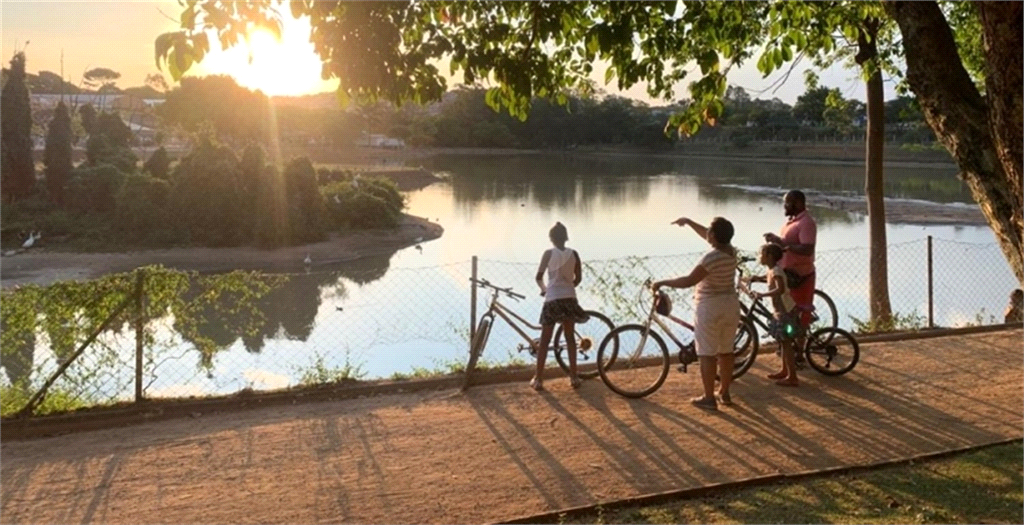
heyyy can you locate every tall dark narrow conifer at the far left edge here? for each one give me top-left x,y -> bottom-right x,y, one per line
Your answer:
0,51 -> 36,202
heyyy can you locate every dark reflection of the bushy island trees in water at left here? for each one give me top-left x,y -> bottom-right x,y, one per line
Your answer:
182,251 -> 395,362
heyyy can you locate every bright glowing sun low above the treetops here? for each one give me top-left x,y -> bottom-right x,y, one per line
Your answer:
186,16 -> 338,96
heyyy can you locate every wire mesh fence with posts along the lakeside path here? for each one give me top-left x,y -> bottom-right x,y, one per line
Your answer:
0,238 -> 1018,417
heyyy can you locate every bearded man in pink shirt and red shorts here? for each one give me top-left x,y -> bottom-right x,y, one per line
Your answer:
764,189 -> 818,329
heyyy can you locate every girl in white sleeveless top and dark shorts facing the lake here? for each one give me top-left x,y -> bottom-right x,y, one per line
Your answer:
529,222 -> 589,391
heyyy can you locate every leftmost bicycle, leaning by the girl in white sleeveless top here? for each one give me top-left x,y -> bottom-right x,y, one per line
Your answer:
468,278 -> 614,379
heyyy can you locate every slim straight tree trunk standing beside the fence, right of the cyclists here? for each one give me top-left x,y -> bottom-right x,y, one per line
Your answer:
855,18 -> 893,325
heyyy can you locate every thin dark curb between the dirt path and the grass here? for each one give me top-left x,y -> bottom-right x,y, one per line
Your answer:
494,438 -> 1024,524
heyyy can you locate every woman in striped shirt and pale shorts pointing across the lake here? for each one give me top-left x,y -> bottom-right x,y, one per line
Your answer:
653,217 -> 739,410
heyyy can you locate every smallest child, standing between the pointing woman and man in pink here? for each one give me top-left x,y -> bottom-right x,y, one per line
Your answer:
755,244 -> 800,387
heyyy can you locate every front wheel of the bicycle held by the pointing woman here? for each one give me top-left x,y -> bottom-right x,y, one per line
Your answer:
597,324 -> 669,398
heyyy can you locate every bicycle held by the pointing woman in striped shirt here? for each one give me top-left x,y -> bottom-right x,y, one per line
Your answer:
597,279 -> 759,398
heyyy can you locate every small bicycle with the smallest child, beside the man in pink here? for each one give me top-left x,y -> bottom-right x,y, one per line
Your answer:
736,258 -> 860,376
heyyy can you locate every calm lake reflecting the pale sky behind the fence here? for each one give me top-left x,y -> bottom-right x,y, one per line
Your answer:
8,155 -> 1017,396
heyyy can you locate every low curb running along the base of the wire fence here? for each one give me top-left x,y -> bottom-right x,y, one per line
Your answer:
0,324 -> 1021,440
